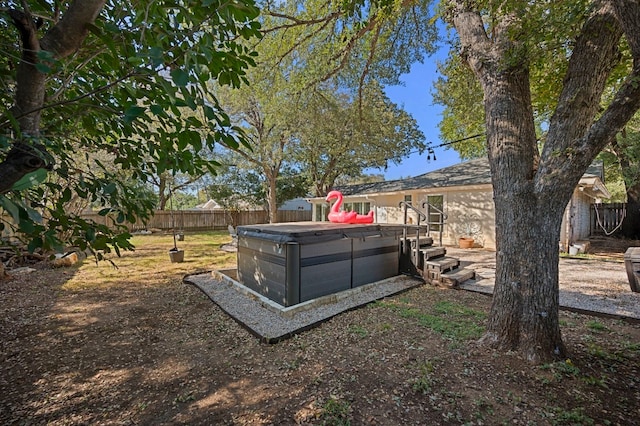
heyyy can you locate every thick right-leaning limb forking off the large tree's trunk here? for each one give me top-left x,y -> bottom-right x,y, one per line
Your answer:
537,2 -> 633,191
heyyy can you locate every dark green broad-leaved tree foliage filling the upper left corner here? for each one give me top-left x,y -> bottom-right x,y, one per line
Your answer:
0,0 -> 261,251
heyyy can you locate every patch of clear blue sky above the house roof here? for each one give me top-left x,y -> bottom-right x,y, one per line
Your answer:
369,56 -> 461,180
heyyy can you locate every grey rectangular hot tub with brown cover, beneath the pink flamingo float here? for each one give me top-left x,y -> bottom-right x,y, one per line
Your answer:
237,222 -> 402,307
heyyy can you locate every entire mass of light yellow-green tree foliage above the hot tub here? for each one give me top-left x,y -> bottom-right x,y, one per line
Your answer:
211,1 -> 433,220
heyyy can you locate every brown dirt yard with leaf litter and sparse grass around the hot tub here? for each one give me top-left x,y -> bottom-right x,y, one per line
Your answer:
0,233 -> 640,425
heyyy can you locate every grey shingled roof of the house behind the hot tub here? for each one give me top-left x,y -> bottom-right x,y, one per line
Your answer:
337,158 -> 491,196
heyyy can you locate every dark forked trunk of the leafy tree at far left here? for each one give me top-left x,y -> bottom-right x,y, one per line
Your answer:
0,0 -> 105,194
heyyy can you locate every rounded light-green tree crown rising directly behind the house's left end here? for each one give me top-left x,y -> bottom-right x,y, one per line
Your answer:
296,82 -> 425,197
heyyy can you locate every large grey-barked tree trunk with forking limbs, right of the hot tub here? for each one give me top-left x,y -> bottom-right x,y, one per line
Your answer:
453,0 -> 640,362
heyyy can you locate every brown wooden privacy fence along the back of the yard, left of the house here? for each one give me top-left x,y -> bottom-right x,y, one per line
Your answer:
82,210 -> 311,231
